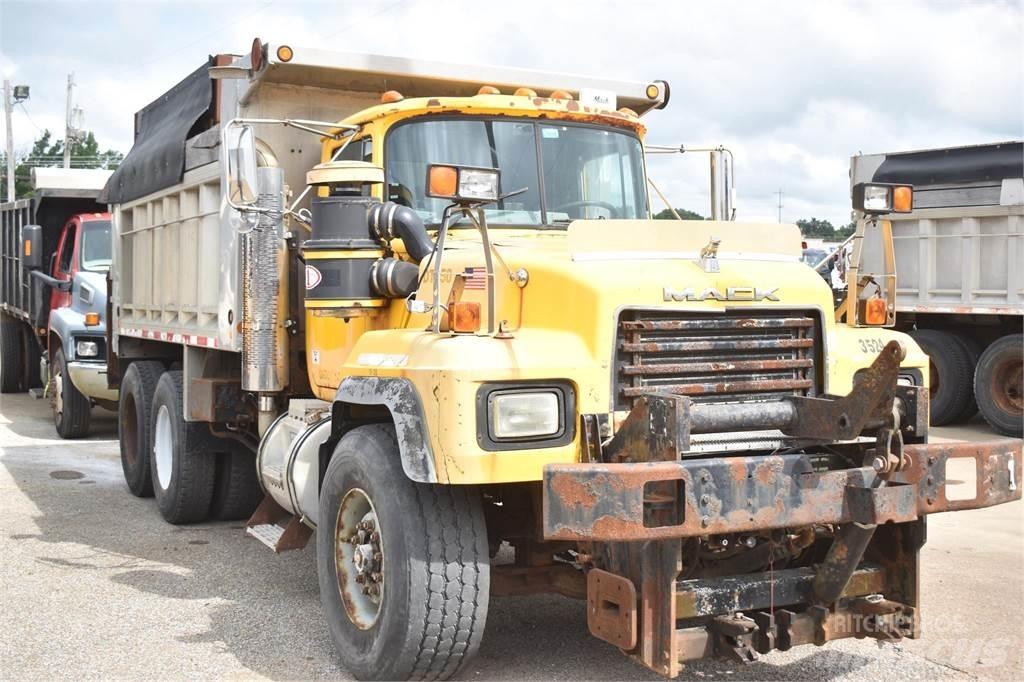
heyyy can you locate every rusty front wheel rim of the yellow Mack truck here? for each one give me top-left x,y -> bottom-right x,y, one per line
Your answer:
334,487 -> 384,630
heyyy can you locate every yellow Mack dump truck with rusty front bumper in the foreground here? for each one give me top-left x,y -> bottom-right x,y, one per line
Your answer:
97,40 -> 1021,679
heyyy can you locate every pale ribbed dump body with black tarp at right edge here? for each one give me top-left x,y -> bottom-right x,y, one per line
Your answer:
851,142 -> 1024,315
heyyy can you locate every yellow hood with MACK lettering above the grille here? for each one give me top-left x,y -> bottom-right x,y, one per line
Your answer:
419,220 -> 833,361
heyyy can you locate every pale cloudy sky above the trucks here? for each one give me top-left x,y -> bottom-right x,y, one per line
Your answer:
0,0 -> 1024,226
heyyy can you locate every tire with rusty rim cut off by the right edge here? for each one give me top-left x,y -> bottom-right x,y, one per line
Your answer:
974,334 -> 1024,438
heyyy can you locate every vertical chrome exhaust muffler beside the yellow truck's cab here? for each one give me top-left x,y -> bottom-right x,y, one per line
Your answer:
242,167 -> 288,433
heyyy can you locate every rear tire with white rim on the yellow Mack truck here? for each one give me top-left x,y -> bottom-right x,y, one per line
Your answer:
151,371 -> 217,523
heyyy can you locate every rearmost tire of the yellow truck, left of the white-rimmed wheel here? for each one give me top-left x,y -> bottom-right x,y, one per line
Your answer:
118,360 -> 164,498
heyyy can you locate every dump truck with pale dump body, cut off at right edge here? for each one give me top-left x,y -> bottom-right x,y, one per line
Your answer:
850,141 -> 1024,438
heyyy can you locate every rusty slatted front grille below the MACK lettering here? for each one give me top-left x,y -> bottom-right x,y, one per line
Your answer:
614,309 -> 821,410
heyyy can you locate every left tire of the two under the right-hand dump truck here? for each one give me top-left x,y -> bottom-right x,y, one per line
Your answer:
910,329 -> 974,426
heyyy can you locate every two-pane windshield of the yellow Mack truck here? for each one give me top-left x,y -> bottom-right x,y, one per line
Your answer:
384,118 -> 647,226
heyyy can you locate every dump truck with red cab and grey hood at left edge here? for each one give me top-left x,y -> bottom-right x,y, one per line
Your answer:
0,168 -> 118,438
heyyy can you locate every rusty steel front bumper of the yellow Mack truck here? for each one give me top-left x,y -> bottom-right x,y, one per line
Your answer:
544,439 -> 1022,542
